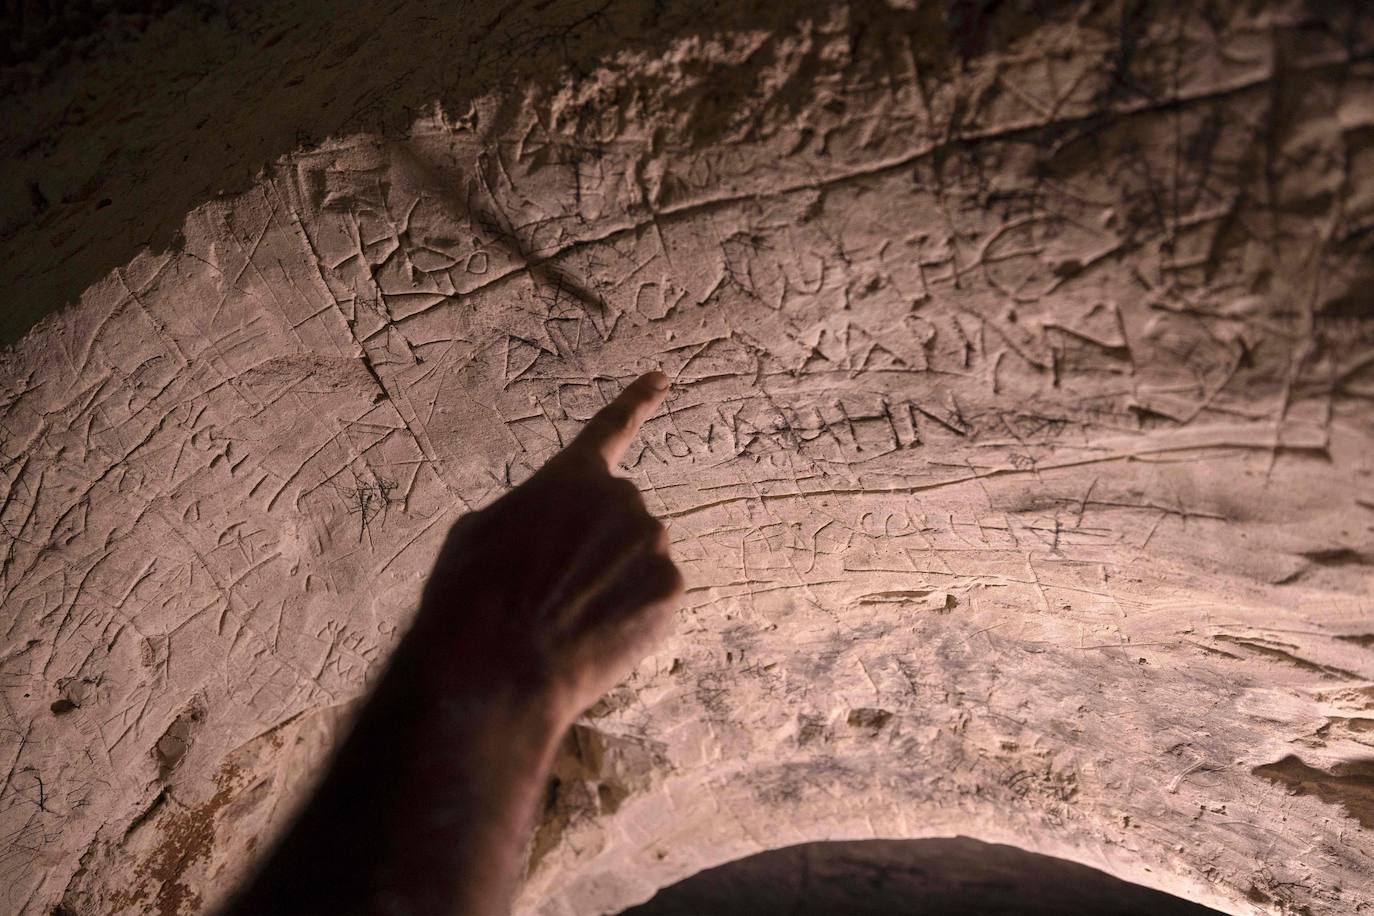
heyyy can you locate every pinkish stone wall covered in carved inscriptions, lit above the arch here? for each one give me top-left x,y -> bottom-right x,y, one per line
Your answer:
0,4 -> 1374,916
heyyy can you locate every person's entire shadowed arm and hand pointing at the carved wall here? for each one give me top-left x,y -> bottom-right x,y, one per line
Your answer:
224,372 -> 682,916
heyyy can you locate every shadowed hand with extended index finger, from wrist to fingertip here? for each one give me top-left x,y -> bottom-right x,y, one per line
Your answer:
411,372 -> 683,721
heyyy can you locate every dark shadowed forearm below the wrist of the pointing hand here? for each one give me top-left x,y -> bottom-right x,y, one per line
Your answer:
227,623 -> 566,916
